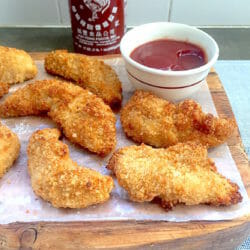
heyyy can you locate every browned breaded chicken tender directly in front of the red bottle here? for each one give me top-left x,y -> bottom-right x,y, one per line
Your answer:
45,50 -> 122,108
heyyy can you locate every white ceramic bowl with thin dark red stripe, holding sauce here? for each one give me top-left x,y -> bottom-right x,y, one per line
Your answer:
120,22 -> 219,101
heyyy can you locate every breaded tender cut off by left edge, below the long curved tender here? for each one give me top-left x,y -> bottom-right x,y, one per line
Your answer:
0,123 -> 20,178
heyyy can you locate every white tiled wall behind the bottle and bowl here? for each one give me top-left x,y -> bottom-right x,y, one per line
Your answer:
0,0 -> 250,26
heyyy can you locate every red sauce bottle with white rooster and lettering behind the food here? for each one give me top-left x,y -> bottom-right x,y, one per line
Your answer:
69,0 -> 125,55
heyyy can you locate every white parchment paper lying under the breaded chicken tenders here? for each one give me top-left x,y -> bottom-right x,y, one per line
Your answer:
0,59 -> 250,224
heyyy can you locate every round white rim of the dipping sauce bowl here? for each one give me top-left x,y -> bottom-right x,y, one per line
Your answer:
120,22 -> 219,76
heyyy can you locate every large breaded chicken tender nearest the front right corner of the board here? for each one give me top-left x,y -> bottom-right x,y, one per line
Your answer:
108,142 -> 242,209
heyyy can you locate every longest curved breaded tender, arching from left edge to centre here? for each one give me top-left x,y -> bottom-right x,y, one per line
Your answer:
0,79 -> 116,156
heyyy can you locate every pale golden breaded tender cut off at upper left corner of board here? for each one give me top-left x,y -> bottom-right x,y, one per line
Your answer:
0,46 -> 37,84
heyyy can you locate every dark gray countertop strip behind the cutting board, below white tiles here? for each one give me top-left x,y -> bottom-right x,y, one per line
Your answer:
0,27 -> 250,60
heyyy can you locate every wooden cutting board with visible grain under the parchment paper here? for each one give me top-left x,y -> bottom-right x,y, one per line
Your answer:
0,53 -> 250,250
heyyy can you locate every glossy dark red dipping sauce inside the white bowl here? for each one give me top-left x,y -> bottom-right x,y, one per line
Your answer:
130,39 -> 207,71
